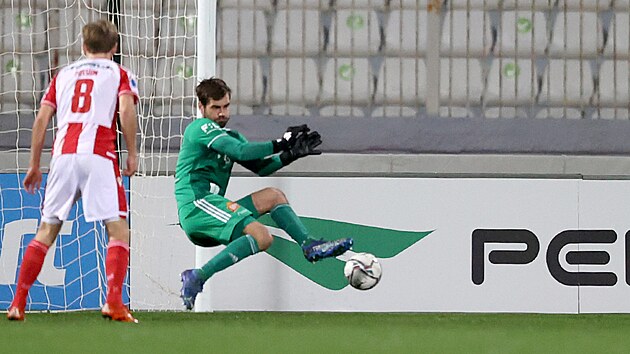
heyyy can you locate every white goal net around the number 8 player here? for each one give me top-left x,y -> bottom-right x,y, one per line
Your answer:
0,0 -> 197,310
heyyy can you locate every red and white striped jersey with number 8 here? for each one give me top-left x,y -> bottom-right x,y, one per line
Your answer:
41,59 -> 138,160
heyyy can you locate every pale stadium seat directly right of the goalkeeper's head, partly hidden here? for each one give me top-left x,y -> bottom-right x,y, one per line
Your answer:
217,58 -> 263,106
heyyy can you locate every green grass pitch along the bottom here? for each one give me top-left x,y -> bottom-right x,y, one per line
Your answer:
0,311 -> 630,353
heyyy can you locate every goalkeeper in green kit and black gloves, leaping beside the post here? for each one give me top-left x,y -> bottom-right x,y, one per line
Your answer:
175,78 -> 352,310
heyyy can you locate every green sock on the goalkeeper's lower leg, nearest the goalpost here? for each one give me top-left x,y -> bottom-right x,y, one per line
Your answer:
197,235 -> 260,281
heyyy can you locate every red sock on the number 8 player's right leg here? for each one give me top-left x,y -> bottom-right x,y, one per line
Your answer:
105,240 -> 129,306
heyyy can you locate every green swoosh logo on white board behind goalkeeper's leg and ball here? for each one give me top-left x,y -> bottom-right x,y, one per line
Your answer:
258,215 -> 433,290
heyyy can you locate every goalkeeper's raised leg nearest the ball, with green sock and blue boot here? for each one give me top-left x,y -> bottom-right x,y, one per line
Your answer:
237,188 -> 353,262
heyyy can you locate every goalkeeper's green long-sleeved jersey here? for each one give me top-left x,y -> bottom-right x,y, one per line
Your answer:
175,118 -> 283,209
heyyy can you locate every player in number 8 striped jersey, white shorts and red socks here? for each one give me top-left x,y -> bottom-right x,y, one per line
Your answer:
7,20 -> 138,322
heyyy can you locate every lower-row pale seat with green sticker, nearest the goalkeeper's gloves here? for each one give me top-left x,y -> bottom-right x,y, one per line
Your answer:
320,58 -> 374,106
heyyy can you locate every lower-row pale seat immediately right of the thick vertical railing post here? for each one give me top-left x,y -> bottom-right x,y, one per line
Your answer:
440,58 -> 483,109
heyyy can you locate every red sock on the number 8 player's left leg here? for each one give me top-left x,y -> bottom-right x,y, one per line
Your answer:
11,240 -> 48,310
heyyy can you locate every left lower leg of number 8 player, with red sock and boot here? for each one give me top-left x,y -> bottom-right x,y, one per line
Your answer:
7,222 -> 61,321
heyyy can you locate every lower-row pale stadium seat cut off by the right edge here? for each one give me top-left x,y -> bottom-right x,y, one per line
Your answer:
596,60 -> 630,108
